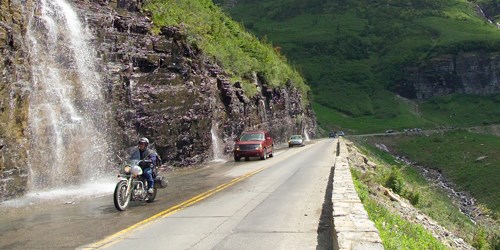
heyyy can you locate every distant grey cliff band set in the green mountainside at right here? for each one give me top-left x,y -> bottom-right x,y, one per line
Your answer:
399,53 -> 500,99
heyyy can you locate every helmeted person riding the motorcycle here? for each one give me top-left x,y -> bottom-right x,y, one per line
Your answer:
130,137 -> 157,194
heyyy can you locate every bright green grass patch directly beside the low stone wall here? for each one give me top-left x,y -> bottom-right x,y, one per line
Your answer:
351,170 -> 446,249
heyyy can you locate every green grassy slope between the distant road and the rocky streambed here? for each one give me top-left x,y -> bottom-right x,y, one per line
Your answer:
360,130 -> 500,217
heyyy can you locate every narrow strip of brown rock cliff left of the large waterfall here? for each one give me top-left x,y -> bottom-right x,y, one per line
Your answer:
0,1 -> 31,200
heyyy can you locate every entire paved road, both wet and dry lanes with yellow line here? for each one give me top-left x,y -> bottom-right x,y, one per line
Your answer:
0,139 -> 336,249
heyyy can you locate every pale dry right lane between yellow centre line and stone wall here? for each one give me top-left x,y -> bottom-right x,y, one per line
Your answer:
86,140 -> 336,250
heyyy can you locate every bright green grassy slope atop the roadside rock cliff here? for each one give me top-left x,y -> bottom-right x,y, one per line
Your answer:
144,0 -> 309,103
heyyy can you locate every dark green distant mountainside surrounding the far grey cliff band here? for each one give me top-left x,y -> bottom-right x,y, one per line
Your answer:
216,0 -> 500,132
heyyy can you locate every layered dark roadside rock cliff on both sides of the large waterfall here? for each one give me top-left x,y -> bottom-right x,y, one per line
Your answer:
0,0 -> 316,200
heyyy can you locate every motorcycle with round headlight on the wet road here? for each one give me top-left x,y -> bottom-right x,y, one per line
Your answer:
113,160 -> 168,211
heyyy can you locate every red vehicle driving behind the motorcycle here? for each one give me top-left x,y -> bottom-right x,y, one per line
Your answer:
233,130 -> 274,161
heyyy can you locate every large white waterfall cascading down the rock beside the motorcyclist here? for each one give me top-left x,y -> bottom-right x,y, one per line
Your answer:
27,0 -> 111,190
